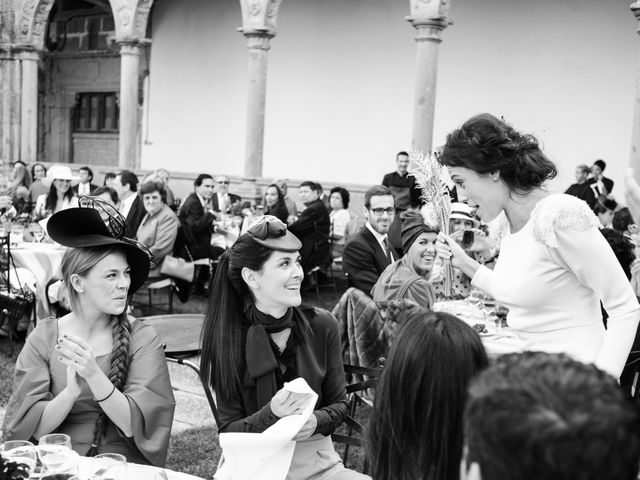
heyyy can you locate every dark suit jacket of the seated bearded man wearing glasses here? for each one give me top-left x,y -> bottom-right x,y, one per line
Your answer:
342,226 -> 391,296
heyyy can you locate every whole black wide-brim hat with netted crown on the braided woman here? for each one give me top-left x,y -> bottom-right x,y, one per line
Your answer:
47,197 -> 152,295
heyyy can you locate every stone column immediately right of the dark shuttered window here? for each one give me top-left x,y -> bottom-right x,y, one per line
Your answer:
118,41 -> 142,170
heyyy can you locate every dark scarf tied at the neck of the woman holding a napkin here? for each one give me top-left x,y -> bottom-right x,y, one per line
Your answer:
245,304 -> 295,408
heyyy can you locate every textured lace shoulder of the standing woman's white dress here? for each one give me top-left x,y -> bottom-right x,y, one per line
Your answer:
531,194 -> 600,248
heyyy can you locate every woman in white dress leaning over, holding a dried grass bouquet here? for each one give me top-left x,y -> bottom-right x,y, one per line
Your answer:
436,114 -> 640,377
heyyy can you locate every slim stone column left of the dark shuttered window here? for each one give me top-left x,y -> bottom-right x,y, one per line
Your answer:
19,50 -> 40,164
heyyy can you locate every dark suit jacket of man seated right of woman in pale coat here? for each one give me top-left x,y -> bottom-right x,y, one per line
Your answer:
178,193 -> 216,258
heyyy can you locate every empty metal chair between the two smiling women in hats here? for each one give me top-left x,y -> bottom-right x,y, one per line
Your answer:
138,313 -> 220,425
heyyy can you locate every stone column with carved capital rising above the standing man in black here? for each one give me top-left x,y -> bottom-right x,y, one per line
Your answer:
407,0 -> 452,153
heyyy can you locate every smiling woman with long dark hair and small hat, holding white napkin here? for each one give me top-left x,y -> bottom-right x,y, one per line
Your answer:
201,215 -> 369,480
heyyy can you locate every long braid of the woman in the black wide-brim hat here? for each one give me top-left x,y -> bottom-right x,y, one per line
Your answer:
90,308 -> 131,453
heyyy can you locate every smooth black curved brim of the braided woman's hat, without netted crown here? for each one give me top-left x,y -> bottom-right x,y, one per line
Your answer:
47,208 -> 151,295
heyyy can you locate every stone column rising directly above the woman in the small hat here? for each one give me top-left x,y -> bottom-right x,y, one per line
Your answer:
242,30 -> 275,178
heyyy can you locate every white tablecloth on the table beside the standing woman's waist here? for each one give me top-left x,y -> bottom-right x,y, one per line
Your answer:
433,300 -> 524,356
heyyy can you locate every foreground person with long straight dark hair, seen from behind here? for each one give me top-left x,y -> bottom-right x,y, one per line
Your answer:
366,306 -> 488,480
